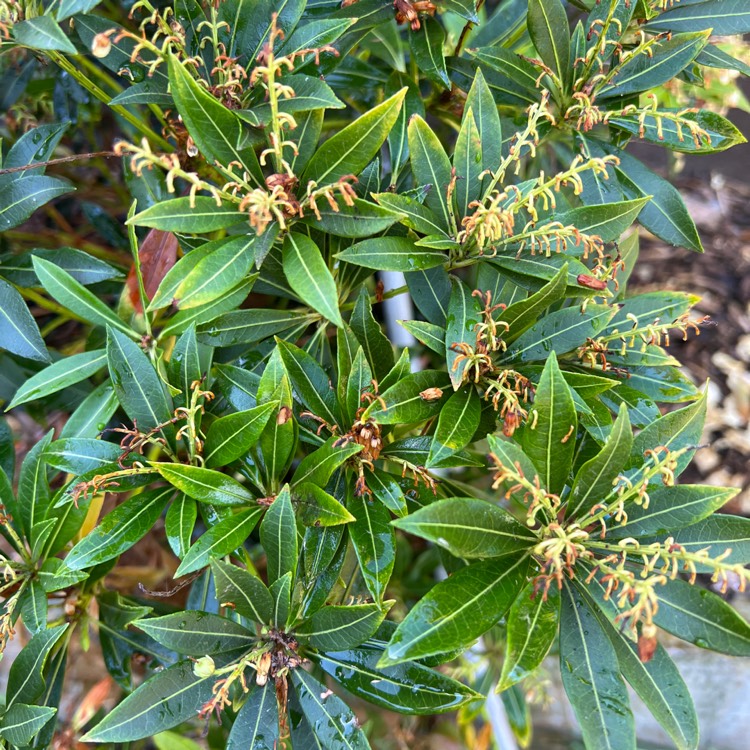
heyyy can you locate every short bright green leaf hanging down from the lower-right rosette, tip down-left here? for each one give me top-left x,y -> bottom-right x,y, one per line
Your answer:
497,582 -> 560,693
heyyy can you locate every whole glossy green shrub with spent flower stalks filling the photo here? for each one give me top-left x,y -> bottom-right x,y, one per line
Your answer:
0,0 -> 750,750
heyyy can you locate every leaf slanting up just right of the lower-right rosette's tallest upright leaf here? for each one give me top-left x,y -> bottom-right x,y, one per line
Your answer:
566,404 -> 633,518
